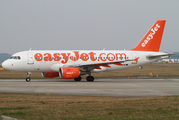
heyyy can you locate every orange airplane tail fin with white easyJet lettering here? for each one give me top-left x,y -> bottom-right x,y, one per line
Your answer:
131,20 -> 166,52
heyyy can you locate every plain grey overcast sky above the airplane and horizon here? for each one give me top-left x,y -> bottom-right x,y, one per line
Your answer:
0,0 -> 179,54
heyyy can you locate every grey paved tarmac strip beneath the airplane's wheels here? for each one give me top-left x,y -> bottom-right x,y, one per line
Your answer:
0,78 -> 179,97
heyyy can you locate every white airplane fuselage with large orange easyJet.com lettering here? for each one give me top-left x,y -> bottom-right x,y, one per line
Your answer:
2,50 -> 168,72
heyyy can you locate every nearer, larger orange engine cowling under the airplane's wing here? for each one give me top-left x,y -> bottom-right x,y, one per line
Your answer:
59,67 -> 80,79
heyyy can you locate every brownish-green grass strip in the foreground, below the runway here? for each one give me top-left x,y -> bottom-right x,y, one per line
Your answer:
0,93 -> 179,120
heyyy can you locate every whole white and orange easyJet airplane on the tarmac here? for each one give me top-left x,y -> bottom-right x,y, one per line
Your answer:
2,20 -> 170,82
